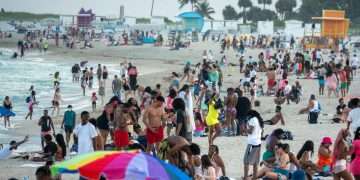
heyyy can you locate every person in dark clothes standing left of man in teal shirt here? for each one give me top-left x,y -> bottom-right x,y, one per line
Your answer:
38,109 -> 56,149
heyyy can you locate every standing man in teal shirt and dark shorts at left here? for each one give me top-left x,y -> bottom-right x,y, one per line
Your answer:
61,105 -> 76,146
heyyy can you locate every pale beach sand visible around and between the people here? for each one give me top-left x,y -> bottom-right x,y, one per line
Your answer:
0,35 -> 360,180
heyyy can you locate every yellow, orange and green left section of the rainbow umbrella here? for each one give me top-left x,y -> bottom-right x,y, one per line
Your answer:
51,151 -> 121,175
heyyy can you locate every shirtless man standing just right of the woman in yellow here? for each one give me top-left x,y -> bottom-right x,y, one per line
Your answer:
224,88 -> 237,136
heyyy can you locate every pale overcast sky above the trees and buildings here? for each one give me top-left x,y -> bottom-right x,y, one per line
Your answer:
0,0 -> 299,19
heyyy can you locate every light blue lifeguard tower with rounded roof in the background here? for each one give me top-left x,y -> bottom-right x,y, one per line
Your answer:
177,12 -> 204,32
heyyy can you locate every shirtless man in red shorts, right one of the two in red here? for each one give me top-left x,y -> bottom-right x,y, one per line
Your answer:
143,96 -> 166,153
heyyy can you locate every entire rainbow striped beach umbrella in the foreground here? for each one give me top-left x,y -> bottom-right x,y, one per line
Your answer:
51,151 -> 190,180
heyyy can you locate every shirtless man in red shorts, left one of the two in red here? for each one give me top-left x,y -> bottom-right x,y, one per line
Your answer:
114,106 -> 131,150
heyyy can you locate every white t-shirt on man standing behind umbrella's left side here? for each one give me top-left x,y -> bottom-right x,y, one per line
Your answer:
74,122 -> 97,154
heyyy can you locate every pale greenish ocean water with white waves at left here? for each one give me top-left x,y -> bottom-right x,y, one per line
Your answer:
0,49 -> 103,123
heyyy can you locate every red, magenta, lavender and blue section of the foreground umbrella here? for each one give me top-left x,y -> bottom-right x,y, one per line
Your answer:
79,152 -> 190,180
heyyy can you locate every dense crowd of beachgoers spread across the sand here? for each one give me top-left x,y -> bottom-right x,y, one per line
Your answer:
0,31 -> 360,180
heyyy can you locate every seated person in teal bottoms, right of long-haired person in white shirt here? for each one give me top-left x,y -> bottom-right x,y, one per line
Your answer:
257,143 -> 290,180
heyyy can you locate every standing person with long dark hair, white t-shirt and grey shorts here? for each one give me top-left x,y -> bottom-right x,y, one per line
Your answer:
244,110 -> 263,179
